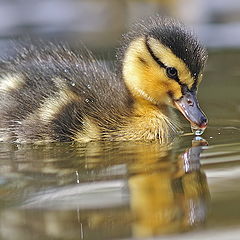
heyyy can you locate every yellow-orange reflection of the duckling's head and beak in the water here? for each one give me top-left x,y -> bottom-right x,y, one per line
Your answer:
128,137 -> 209,237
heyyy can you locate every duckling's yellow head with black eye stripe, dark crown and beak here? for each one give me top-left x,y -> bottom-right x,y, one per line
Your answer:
120,16 -> 207,132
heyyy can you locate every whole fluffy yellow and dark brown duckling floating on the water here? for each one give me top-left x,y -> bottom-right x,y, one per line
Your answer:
0,16 -> 207,143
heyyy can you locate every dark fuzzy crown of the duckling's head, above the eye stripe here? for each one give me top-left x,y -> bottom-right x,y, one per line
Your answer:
117,15 -> 207,82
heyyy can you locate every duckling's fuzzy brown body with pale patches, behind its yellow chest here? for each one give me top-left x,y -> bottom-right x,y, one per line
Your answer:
0,44 -> 131,142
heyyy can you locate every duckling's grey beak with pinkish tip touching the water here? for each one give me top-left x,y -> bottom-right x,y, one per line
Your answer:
174,91 -> 208,130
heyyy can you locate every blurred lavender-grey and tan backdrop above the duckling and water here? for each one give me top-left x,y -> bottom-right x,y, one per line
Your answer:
0,0 -> 240,52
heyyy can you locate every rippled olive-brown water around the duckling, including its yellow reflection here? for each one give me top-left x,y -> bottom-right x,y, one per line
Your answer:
0,51 -> 240,240
